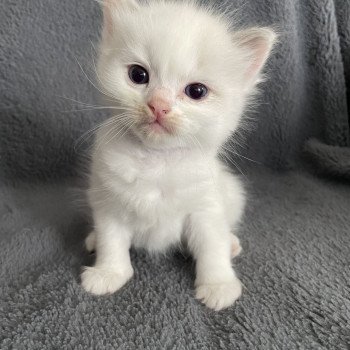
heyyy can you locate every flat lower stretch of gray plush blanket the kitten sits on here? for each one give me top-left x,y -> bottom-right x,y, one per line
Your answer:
0,170 -> 350,350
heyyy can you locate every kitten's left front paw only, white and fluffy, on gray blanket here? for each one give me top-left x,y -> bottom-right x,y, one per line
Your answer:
81,267 -> 134,295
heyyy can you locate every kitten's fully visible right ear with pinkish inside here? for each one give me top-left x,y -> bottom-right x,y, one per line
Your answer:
234,27 -> 277,87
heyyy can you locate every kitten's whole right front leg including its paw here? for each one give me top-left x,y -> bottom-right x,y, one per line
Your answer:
188,210 -> 242,311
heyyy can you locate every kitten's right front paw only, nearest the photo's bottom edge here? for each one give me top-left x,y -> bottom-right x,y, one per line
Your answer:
196,277 -> 242,311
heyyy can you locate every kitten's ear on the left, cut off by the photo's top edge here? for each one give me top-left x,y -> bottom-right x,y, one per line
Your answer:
101,0 -> 139,36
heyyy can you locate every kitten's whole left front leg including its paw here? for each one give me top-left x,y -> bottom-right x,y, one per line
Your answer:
81,213 -> 134,295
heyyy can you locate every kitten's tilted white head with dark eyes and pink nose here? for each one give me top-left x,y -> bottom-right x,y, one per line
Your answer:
98,0 -> 275,149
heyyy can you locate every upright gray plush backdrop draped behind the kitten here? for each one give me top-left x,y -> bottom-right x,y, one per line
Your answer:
0,0 -> 350,178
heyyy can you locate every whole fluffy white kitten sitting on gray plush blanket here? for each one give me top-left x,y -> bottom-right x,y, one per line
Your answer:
81,0 -> 275,310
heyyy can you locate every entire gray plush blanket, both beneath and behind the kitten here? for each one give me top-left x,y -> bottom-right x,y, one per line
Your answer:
0,0 -> 350,349
